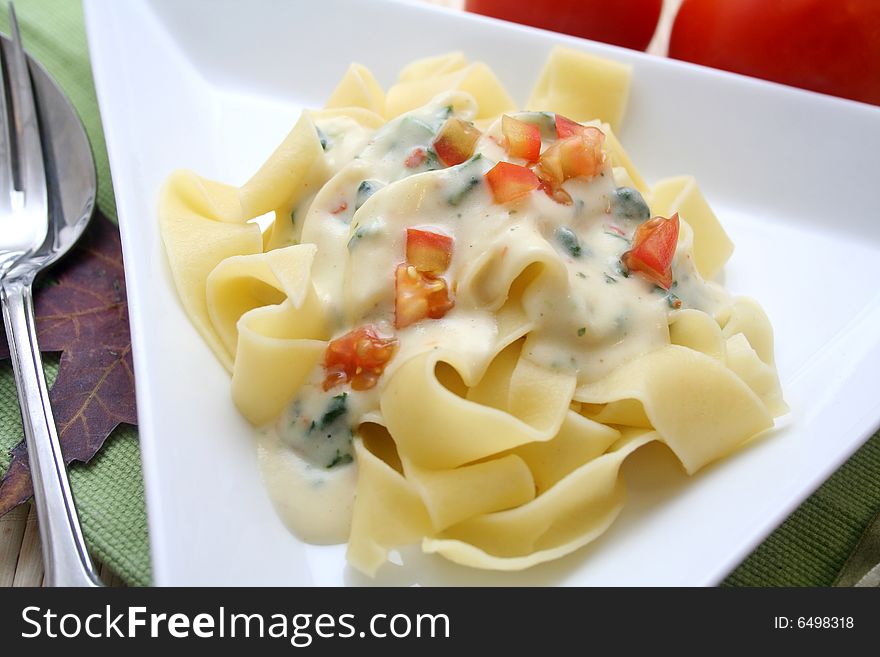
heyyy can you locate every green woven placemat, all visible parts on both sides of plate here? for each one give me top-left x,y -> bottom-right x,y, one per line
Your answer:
0,0 -> 880,586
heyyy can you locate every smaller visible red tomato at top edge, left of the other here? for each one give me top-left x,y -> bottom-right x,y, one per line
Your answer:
465,0 -> 663,50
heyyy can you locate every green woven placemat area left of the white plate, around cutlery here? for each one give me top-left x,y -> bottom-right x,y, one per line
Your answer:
0,0 -> 150,585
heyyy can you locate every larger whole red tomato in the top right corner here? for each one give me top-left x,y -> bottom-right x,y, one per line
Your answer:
669,0 -> 880,105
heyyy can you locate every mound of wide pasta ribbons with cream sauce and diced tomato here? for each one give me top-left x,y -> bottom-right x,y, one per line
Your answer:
159,48 -> 786,575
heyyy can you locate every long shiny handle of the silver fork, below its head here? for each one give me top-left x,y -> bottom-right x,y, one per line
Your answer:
0,276 -> 101,587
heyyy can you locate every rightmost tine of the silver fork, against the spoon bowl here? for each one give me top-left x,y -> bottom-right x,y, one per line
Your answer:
7,3 -> 46,209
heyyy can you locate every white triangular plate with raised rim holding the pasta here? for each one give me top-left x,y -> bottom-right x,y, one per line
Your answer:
86,0 -> 880,585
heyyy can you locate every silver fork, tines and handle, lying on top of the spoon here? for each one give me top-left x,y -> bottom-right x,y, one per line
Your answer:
0,4 -> 100,586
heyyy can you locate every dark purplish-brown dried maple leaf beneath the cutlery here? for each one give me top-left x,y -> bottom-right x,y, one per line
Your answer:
0,215 -> 137,516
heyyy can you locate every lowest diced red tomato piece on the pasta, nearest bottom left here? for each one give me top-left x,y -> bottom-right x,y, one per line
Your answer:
323,325 -> 397,390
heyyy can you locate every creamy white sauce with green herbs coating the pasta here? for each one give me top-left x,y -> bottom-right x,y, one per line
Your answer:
260,93 -> 729,543
